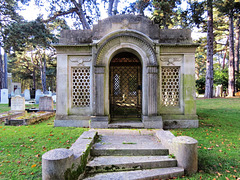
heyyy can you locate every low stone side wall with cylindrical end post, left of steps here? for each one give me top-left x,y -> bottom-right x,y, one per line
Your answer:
42,131 -> 97,180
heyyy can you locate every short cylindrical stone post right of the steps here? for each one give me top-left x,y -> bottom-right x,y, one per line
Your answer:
172,136 -> 198,175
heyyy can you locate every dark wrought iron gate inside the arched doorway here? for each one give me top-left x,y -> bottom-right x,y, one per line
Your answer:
110,53 -> 142,120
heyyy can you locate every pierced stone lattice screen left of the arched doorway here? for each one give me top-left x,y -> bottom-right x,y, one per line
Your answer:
72,67 -> 90,107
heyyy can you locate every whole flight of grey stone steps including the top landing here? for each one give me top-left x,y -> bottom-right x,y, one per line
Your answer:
83,131 -> 184,180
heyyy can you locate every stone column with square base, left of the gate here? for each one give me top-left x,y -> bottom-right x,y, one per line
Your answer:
90,66 -> 108,128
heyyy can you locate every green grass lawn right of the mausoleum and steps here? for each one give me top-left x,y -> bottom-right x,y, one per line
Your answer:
171,98 -> 240,180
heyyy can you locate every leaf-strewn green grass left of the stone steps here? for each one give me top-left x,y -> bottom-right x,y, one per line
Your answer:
0,117 -> 88,180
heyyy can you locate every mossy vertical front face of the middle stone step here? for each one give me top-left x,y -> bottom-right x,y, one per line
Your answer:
86,160 -> 177,173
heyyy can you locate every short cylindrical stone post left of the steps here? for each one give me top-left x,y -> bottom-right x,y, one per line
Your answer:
42,148 -> 74,180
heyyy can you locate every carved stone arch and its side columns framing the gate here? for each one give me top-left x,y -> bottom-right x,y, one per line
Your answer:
92,30 -> 162,128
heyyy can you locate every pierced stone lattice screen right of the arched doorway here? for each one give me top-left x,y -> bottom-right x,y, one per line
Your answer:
162,67 -> 180,106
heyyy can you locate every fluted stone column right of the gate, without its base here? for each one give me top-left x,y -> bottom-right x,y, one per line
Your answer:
147,66 -> 158,116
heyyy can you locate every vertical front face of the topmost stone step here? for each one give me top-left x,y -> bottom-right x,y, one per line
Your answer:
91,149 -> 169,156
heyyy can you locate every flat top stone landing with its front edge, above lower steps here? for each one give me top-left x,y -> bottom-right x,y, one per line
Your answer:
91,135 -> 168,156
